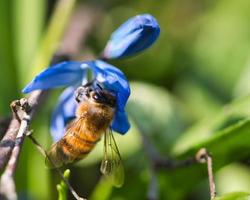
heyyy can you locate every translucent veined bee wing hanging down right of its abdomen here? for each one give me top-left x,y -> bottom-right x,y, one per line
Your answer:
100,129 -> 124,187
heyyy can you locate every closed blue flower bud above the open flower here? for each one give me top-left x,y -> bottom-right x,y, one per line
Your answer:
103,14 -> 160,59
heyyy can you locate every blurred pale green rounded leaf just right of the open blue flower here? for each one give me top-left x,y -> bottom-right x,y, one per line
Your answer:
127,82 -> 183,152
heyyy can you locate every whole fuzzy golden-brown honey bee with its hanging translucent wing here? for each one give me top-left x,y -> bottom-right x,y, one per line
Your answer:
46,83 -> 124,187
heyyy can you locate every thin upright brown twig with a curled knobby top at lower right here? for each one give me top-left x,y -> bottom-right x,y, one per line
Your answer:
196,148 -> 216,199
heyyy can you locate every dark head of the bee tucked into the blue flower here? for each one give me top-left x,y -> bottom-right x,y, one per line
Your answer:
75,83 -> 116,108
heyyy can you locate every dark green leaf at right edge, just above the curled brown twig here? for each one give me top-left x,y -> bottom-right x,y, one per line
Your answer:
178,120 -> 250,164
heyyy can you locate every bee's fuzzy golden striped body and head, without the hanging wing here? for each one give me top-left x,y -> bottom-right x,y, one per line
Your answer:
46,85 -> 116,167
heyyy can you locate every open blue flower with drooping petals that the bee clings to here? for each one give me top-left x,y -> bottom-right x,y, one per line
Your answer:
23,60 -> 130,141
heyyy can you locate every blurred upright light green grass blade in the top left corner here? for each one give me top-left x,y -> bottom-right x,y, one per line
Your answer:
12,0 -> 46,87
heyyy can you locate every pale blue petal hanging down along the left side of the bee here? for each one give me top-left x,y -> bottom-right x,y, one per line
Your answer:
50,87 -> 77,142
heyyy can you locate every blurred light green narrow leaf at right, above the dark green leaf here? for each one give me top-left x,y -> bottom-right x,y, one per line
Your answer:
172,95 -> 250,155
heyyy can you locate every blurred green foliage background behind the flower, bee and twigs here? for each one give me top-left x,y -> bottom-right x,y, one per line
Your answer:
0,0 -> 250,200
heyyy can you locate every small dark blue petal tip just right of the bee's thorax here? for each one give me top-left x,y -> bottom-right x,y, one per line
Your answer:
111,110 -> 130,135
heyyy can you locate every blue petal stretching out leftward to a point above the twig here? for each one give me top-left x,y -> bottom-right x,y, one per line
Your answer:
22,61 -> 86,93
